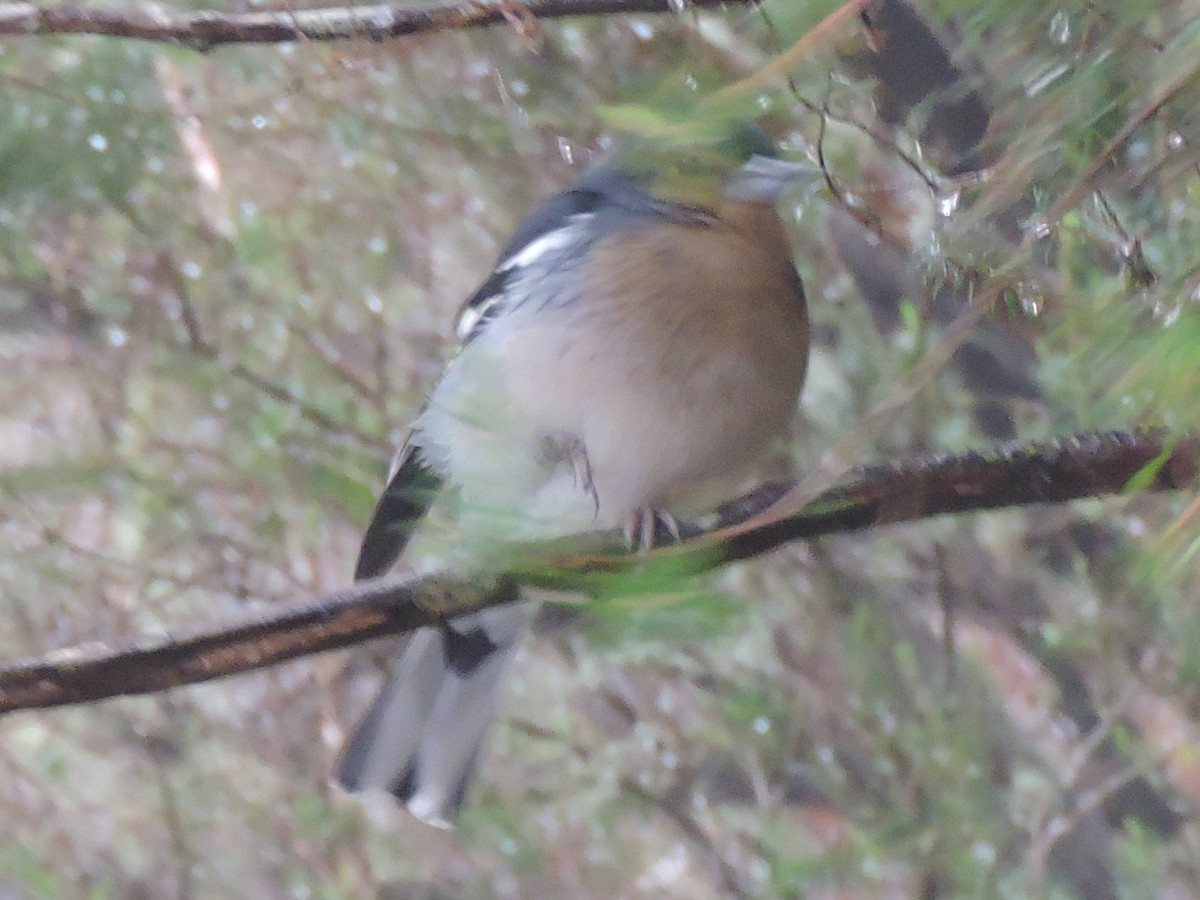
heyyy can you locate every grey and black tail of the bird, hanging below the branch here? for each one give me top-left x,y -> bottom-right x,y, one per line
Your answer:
337,602 -> 534,827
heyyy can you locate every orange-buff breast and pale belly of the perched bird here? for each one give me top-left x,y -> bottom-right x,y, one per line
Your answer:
420,214 -> 808,540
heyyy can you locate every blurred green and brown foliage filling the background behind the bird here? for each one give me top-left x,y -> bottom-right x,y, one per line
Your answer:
0,0 -> 1200,898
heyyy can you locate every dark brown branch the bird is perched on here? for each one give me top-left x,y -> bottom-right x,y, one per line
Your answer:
0,430 -> 1200,713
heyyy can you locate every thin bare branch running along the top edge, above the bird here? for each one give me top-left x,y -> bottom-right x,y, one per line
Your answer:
0,0 -> 755,52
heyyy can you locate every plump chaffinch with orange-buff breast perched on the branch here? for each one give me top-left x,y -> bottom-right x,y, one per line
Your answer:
337,127 -> 809,824
